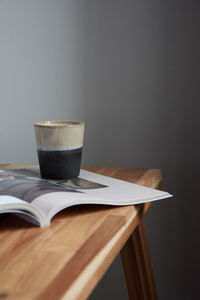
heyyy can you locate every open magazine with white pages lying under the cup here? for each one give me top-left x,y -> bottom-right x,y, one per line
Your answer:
0,169 -> 171,227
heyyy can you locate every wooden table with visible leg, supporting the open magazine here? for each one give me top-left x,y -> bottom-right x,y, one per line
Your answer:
0,165 -> 162,300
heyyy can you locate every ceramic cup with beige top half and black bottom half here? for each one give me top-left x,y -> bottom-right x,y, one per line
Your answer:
34,121 -> 85,179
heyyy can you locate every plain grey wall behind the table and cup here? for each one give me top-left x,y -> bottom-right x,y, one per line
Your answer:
0,0 -> 200,300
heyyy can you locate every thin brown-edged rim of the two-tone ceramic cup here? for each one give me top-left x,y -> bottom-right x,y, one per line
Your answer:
34,120 -> 85,128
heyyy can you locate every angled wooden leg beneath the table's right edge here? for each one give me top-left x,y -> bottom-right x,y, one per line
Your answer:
121,217 -> 157,300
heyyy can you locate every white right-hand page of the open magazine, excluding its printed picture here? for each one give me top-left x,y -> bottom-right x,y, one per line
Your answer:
32,170 -> 171,216
